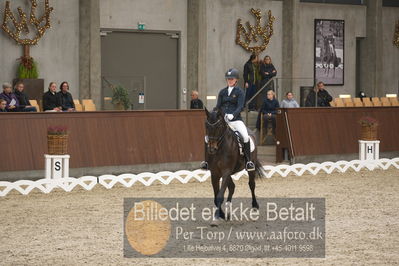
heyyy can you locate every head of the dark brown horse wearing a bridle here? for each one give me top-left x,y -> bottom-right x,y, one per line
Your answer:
205,108 -> 227,154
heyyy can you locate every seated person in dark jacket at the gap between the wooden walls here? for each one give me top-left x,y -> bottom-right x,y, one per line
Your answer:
256,90 -> 280,135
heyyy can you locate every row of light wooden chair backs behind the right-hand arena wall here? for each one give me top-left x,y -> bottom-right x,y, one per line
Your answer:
330,97 -> 399,107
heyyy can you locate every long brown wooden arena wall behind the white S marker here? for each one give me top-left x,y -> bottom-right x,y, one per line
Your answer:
0,110 -> 205,172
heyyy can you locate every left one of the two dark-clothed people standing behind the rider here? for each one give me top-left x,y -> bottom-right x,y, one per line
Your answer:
244,54 -> 258,111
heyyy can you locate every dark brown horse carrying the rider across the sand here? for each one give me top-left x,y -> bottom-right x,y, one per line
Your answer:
205,109 -> 266,226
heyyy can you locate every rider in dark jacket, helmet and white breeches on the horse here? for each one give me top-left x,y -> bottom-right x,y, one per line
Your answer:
201,68 -> 255,171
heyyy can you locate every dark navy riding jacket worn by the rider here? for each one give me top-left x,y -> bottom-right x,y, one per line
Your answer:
216,87 -> 245,121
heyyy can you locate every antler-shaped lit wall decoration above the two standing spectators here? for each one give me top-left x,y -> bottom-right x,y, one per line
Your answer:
236,8 -> 275,55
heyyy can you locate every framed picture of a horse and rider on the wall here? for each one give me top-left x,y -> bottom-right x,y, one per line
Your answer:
314,19 -> 345,86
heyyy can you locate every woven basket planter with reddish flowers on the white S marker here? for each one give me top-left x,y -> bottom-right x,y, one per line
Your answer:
47,126 -> 68,155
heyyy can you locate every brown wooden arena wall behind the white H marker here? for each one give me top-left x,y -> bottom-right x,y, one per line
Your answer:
276,107 -> 399,162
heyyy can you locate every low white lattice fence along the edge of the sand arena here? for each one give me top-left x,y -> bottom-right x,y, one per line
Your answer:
0,158 -> 399,197
